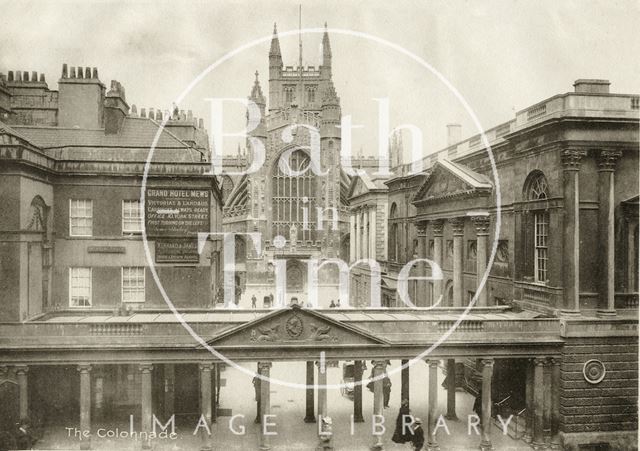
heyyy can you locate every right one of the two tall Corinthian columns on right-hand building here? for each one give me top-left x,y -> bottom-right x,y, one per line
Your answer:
598,150 -> 622,316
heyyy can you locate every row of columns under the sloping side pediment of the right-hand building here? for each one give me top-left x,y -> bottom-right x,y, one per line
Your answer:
418,212 -> 491,307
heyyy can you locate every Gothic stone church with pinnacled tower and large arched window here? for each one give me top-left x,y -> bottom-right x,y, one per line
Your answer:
223,25 -> 349,307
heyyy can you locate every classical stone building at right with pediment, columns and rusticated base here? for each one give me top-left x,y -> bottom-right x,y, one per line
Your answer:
352,80 -> 639,449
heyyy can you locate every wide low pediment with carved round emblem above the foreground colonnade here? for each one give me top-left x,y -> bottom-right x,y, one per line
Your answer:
207,305 -> 387,348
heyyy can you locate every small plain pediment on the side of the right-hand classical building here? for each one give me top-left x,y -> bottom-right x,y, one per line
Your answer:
413,160 -> 492,203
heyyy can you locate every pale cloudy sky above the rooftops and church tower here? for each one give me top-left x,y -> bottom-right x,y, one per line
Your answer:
0,0 -> 640,158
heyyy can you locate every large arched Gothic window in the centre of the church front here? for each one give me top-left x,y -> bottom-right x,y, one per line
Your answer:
272,150 -> 316,242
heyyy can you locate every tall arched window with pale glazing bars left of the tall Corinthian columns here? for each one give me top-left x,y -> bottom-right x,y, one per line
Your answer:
523,171 -> 550,283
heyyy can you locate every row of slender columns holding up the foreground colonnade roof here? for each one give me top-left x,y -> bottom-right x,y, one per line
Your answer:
7,357 -> 560,451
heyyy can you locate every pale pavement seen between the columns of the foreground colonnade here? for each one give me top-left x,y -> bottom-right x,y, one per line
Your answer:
37,361 -> 531,451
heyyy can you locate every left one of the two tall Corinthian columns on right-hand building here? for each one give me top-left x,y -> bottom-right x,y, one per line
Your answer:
562,149 -> 587,315
